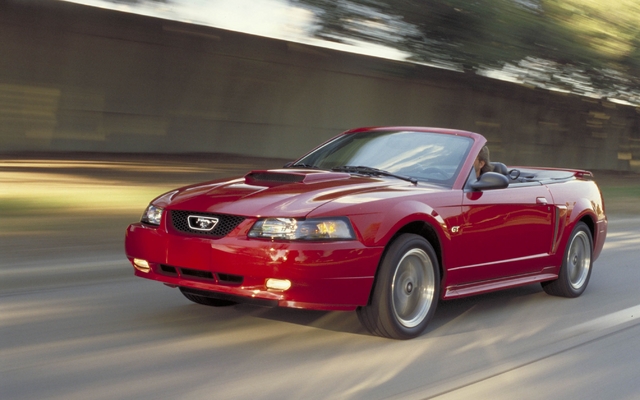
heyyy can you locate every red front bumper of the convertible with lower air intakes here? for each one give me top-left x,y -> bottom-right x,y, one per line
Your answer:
125,221 -> 383,310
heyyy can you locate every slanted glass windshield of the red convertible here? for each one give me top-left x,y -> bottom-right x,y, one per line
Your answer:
296,131 -> 473,185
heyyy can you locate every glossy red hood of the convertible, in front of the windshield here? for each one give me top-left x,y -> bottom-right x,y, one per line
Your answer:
154,169 -> 437,217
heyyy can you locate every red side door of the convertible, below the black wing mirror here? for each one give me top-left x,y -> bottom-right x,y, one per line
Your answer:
449,183 -> 554,283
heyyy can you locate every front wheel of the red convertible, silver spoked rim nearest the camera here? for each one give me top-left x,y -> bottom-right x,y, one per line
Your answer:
357,234 -> 440,339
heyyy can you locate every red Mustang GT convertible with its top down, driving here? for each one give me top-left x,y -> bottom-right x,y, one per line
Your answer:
125,127 -> 607,339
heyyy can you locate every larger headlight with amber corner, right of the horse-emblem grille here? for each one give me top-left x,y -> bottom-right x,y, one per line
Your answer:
249,218 -> 355,240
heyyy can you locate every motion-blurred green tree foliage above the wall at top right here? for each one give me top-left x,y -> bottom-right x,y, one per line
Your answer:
298,0 -> 640,103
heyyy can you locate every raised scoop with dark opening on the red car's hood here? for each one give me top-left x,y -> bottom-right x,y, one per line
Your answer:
244,169 -> 351,186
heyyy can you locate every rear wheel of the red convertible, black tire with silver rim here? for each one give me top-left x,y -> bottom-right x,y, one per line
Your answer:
542,222 -> 593,297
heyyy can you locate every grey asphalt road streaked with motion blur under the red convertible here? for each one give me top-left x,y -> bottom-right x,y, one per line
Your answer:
0,157 -> 640,400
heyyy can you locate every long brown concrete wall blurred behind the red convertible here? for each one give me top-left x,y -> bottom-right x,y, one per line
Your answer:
0,0 -> 640,170
